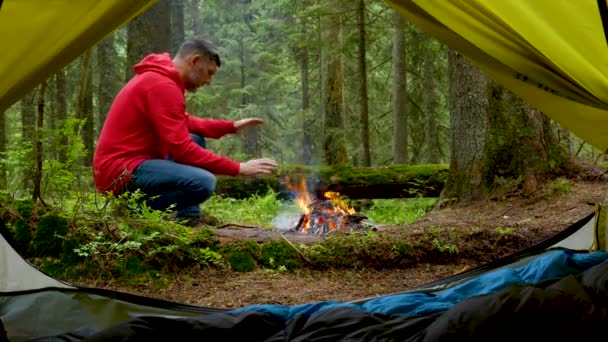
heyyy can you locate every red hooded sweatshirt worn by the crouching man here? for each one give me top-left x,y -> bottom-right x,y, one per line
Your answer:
93,53 -> 240,194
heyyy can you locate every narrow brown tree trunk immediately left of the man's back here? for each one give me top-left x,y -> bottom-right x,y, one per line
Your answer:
76,49 -> 94,166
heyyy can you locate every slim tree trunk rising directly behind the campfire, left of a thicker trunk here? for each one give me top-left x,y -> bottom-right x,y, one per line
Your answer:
300,21 -> 313,165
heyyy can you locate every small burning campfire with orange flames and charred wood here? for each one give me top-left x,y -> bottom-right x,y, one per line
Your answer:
285,177 -> 367,234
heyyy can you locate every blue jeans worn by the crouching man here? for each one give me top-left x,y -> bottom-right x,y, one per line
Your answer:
127,134 -> 216,218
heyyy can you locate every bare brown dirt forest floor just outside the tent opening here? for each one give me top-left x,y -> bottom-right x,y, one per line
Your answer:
79,181 -> 608,308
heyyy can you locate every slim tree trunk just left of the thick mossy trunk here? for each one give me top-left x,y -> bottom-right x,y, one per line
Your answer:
422,33 -> 441,164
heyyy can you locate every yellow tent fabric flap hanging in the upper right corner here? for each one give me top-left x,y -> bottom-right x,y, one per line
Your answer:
387,0 -> 608,150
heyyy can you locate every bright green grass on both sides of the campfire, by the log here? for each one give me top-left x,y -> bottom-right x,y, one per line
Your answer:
201,192 -> 437,228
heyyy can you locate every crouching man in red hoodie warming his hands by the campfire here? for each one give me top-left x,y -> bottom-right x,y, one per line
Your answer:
93,38 -> 277,224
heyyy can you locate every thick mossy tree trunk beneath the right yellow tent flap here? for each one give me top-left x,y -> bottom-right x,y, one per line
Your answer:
441,51 -> 565,204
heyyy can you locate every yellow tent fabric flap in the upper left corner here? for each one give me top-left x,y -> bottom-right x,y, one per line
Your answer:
0,0 -> 156,112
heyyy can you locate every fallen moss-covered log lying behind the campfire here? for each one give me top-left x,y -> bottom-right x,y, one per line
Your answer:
216,164 -> 448,199
